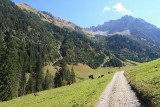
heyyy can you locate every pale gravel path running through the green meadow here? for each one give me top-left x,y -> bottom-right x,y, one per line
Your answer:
96,71 -> 144,107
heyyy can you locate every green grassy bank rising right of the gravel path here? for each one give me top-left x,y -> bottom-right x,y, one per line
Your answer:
125,59 -> 160,107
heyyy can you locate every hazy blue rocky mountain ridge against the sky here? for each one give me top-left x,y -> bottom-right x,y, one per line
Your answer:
88,16 -> 160,45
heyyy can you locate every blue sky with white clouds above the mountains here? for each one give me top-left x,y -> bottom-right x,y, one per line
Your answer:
12,0 -> 160,28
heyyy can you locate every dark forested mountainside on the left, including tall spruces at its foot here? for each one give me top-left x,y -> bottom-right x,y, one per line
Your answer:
0,0 -> 105,100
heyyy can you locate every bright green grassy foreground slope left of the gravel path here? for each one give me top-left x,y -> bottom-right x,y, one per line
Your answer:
0,74 -> 113,107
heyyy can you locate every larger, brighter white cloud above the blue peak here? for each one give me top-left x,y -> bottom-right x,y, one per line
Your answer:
113,3 -> 131,15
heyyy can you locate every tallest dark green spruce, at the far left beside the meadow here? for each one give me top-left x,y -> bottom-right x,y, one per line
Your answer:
1,32 -> 20,100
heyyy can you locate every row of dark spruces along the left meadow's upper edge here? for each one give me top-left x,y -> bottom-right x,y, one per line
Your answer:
0,31 -> 75,101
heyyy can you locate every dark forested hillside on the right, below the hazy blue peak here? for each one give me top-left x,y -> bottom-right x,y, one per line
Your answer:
95,34 -> 160,62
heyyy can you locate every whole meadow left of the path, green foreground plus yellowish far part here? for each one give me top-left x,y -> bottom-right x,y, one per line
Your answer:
0,64 -> 136,107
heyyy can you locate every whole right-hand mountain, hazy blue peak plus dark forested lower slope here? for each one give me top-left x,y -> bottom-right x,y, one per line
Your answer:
88,16 -> 160,62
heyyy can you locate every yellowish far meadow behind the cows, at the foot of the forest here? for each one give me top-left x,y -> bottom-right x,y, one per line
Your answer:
43,61 -> 136,82
